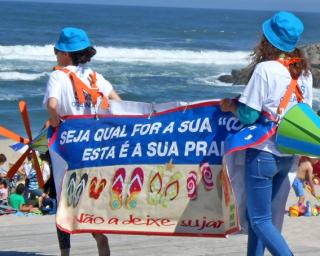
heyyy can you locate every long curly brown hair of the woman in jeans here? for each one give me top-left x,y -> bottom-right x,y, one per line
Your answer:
251,36 -> 310,79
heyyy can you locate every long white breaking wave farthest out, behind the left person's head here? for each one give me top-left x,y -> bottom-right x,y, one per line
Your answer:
0,45 -> 249,65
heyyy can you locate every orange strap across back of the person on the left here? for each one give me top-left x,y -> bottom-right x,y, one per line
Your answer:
54,66 -> 109,109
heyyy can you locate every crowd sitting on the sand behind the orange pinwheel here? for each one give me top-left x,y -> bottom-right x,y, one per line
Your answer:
0,153 -> 56,215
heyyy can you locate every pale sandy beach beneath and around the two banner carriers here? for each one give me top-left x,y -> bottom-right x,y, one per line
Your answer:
0,140 -> 320,256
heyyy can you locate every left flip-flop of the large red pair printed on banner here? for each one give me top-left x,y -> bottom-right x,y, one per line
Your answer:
110,168 -> 126,210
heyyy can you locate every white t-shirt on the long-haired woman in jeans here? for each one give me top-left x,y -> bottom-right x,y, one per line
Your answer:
239,61 -> 312,155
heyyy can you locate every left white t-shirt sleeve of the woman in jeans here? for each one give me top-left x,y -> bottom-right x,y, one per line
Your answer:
239,65 -> 268,111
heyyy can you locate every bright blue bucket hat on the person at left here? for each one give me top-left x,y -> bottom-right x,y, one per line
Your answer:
54,27 -> 91,52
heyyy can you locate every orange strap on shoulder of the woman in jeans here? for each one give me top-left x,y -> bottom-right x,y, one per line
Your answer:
277,58 -> 303,115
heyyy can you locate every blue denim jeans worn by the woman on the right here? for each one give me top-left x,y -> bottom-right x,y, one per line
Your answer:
245,148 -> 293,256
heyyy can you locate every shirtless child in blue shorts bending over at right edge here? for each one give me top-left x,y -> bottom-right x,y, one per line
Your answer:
292,157 -> 319,206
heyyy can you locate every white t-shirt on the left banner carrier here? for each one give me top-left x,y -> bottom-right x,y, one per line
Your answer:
43,65 -> 113,117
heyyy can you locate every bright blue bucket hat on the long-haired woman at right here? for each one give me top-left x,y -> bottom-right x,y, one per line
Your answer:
262,11 -> 304,52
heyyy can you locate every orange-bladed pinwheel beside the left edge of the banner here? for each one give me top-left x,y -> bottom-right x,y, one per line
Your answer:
0,101 -> 48,187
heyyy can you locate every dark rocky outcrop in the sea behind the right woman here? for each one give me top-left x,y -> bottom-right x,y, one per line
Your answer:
218,44 -> 320,88
